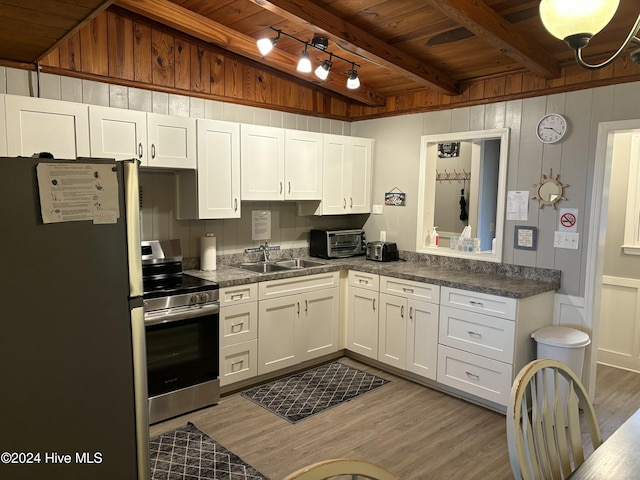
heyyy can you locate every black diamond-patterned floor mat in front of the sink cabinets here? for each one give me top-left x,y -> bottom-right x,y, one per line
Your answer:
242,362 -> 389,423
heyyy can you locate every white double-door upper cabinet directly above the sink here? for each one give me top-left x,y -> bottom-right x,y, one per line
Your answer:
241,124 -> 322,200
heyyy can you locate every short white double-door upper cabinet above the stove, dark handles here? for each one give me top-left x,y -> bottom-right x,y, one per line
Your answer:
89,105 -> 196,169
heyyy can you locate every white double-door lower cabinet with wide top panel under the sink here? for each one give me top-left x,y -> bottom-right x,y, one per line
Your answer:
258,272 -> 340,375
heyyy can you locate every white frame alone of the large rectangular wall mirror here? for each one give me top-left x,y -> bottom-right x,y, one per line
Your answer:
416,128 -> 509,262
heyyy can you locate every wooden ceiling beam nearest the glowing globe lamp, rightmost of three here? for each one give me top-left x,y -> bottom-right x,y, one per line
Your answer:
430,0 -> 560,78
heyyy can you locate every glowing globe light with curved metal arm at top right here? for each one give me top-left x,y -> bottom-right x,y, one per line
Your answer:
540,0 -> 640,70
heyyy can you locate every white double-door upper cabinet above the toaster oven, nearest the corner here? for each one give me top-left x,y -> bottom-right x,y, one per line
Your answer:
316,134 -> 373,215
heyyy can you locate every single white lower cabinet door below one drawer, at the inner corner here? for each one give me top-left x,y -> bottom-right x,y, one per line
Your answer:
347,287 -> 378,360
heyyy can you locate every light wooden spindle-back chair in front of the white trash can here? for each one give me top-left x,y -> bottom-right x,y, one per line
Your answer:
507,359 -> 602,480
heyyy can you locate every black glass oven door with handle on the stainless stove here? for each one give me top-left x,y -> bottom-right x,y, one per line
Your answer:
145,303 -> 220,397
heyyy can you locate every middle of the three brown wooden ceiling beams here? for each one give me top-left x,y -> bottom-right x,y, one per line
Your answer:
251,0 -> 459,95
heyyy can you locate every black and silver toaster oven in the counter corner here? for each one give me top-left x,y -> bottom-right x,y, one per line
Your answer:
309,228 -> 367,258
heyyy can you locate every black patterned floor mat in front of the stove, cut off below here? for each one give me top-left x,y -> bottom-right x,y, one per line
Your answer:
150,423 -> 269,480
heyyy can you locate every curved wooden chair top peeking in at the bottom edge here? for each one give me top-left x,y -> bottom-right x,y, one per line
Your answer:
284,458 -> 398,480
